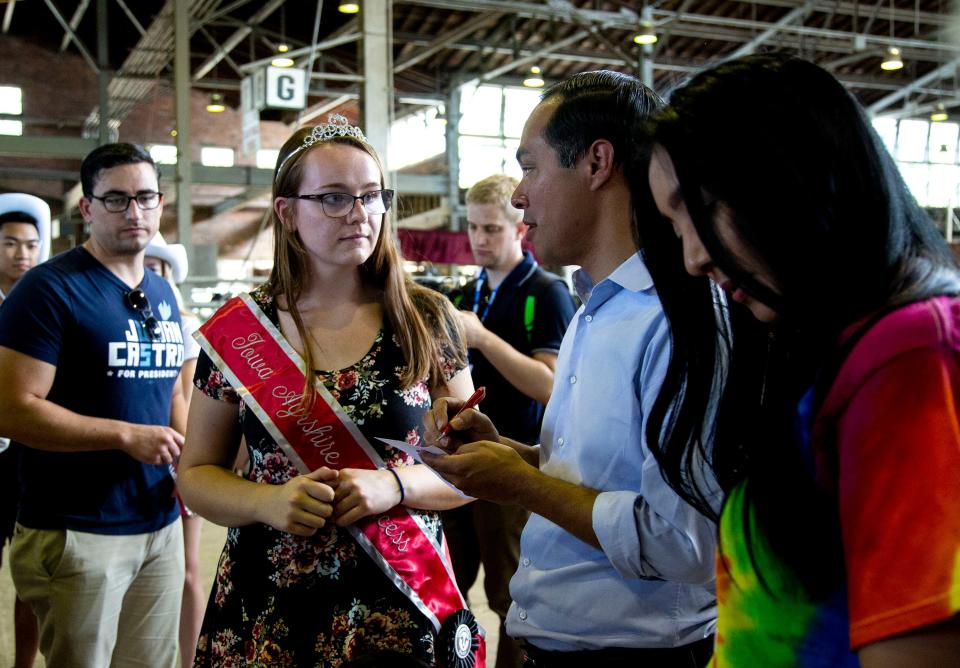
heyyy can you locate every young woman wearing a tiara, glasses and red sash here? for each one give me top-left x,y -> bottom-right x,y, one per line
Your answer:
180,116 -> 482,666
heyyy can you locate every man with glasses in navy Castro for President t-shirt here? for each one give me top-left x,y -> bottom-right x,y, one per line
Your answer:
0,144 -> 186,667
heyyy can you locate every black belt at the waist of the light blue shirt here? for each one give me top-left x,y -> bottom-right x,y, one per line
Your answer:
523,636 -> 713,668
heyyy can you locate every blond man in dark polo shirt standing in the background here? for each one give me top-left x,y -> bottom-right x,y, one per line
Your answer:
444,175 -> 576,668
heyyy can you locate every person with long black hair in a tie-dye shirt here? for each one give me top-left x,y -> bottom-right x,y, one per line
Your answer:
638,54 -> 960,668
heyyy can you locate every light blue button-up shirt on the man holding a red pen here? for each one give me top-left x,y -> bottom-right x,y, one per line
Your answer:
507,254 -> 717,651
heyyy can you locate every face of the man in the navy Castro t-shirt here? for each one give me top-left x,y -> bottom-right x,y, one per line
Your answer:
80,162 -> 163,255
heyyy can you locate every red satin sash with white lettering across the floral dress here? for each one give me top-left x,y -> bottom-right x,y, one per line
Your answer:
196,294 -> 486,668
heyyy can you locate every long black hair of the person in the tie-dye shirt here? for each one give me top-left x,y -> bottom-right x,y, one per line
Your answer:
641,54 -> 958,595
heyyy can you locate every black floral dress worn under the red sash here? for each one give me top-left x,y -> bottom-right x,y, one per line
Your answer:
194,291 -> 458,668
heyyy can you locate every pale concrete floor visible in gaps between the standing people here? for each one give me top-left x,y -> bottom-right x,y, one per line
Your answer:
0,522 -> 498,668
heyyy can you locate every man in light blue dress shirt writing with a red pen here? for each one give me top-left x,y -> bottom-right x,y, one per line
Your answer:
425,72 -> 716,668
